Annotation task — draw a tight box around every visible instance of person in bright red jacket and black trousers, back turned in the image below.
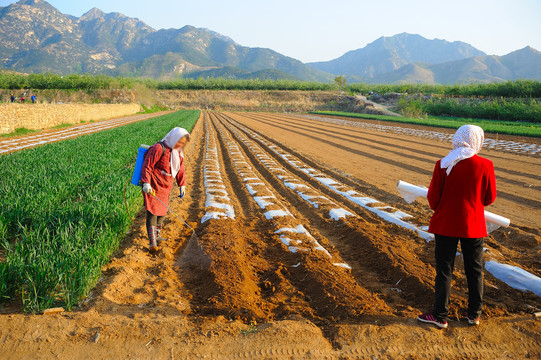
[417,125,496,328]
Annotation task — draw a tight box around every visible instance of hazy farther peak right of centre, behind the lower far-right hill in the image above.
[309,33,485,82]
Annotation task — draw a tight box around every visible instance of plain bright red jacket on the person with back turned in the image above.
[428,155,496,238]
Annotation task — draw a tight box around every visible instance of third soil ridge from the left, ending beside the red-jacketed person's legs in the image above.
[214,112,434,307]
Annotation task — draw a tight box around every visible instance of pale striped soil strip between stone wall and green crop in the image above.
[0,111,171,154]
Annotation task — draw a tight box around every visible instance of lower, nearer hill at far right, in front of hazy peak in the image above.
[370,46,541,84]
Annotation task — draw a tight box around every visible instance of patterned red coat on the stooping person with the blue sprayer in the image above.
[141,143,186,216]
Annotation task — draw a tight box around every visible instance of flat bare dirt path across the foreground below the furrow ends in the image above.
[0,311,541,360]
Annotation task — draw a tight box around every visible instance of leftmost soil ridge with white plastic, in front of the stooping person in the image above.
[184,114,273,322]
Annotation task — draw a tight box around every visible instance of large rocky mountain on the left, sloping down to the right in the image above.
[0,0,331,81]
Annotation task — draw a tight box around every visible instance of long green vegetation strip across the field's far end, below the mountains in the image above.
[0,71,541,98]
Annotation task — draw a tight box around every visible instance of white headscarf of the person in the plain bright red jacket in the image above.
[441,125,485,175]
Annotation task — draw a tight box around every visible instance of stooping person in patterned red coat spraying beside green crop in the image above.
[141,127,190,252]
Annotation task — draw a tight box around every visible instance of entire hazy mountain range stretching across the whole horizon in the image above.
[0,0,541,84]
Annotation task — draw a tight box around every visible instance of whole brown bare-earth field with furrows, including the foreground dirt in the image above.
[0,113,541,359]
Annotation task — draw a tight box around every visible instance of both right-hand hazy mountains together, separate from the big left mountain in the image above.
[308,33,541,84]
